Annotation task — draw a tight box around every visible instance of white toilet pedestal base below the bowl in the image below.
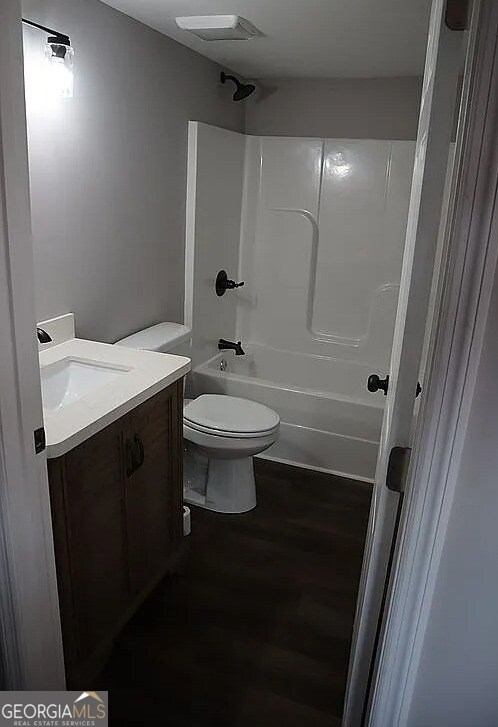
[184,447,257,514]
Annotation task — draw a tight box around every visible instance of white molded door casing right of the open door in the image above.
[369,0,498,727]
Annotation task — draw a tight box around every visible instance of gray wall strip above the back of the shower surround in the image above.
[246,77,422,139]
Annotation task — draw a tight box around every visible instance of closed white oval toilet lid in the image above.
[183,394,280,435]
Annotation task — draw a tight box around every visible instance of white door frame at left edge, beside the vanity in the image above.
[0,0,65,690]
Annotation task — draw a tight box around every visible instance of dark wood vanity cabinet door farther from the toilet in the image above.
[51,422,131,660]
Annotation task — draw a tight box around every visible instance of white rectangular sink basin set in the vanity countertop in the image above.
[41,357,131,411]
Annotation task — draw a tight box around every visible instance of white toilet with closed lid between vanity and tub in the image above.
[116,323,280,513]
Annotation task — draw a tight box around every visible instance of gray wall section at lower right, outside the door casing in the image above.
[408,260,498,727]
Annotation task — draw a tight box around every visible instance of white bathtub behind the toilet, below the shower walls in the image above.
[192,344,383,482]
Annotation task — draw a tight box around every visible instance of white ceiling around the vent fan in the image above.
[97,0,430,78]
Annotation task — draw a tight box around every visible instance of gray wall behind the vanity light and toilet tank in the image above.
[23,0,244,341]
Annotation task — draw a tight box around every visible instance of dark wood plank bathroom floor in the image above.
[94,460,371,727]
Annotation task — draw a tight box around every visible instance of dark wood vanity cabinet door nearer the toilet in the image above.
[126,382,183,594]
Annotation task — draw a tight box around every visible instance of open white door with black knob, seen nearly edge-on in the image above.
[343,0,465,727]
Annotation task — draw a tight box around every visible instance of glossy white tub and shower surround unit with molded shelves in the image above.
[185,122,415,480]
